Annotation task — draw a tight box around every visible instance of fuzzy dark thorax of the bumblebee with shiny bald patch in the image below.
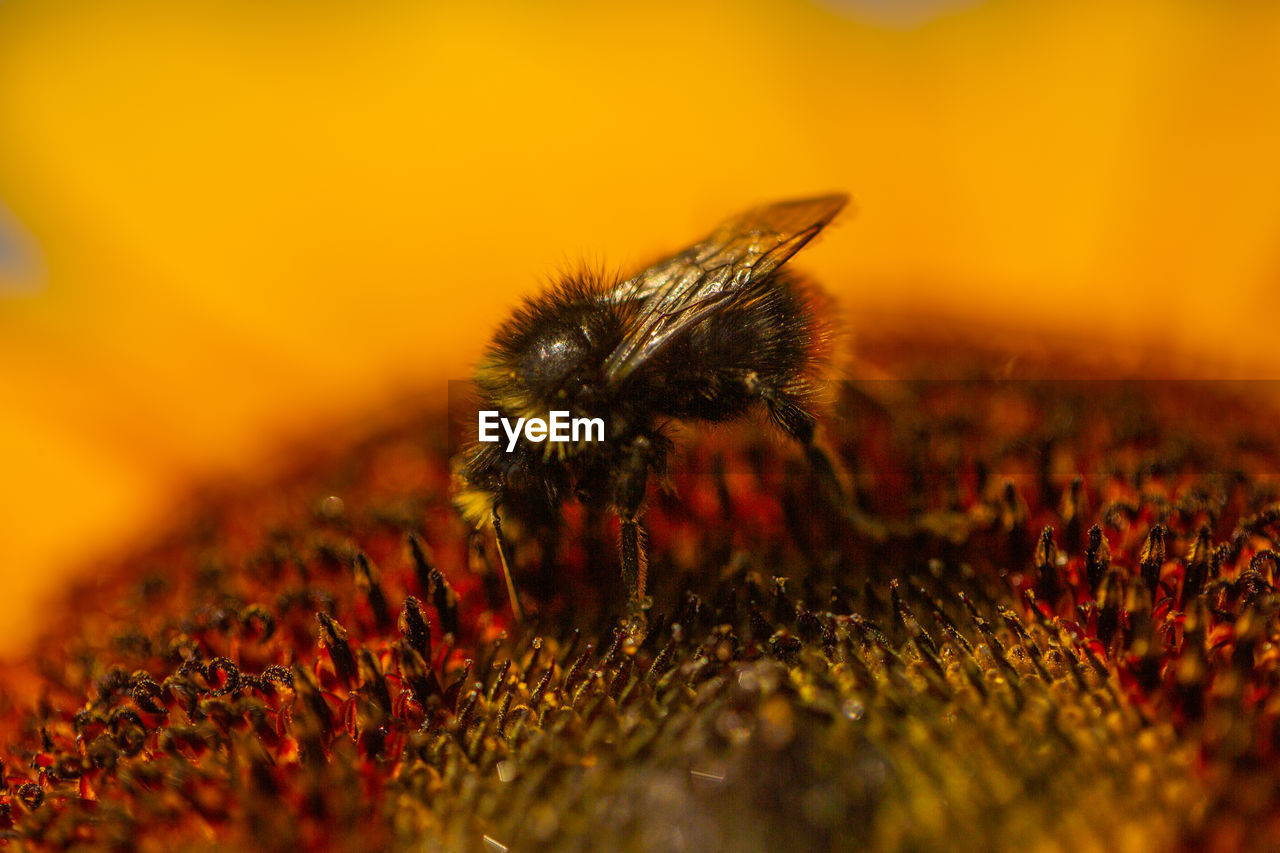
[476,277,627,418]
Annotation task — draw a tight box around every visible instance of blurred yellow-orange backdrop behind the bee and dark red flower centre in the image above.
[0,0,1280,651]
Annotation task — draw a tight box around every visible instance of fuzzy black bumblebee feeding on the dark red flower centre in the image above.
[453,195,849,621]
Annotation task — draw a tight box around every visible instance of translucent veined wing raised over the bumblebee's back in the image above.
[604,195,849,386]
